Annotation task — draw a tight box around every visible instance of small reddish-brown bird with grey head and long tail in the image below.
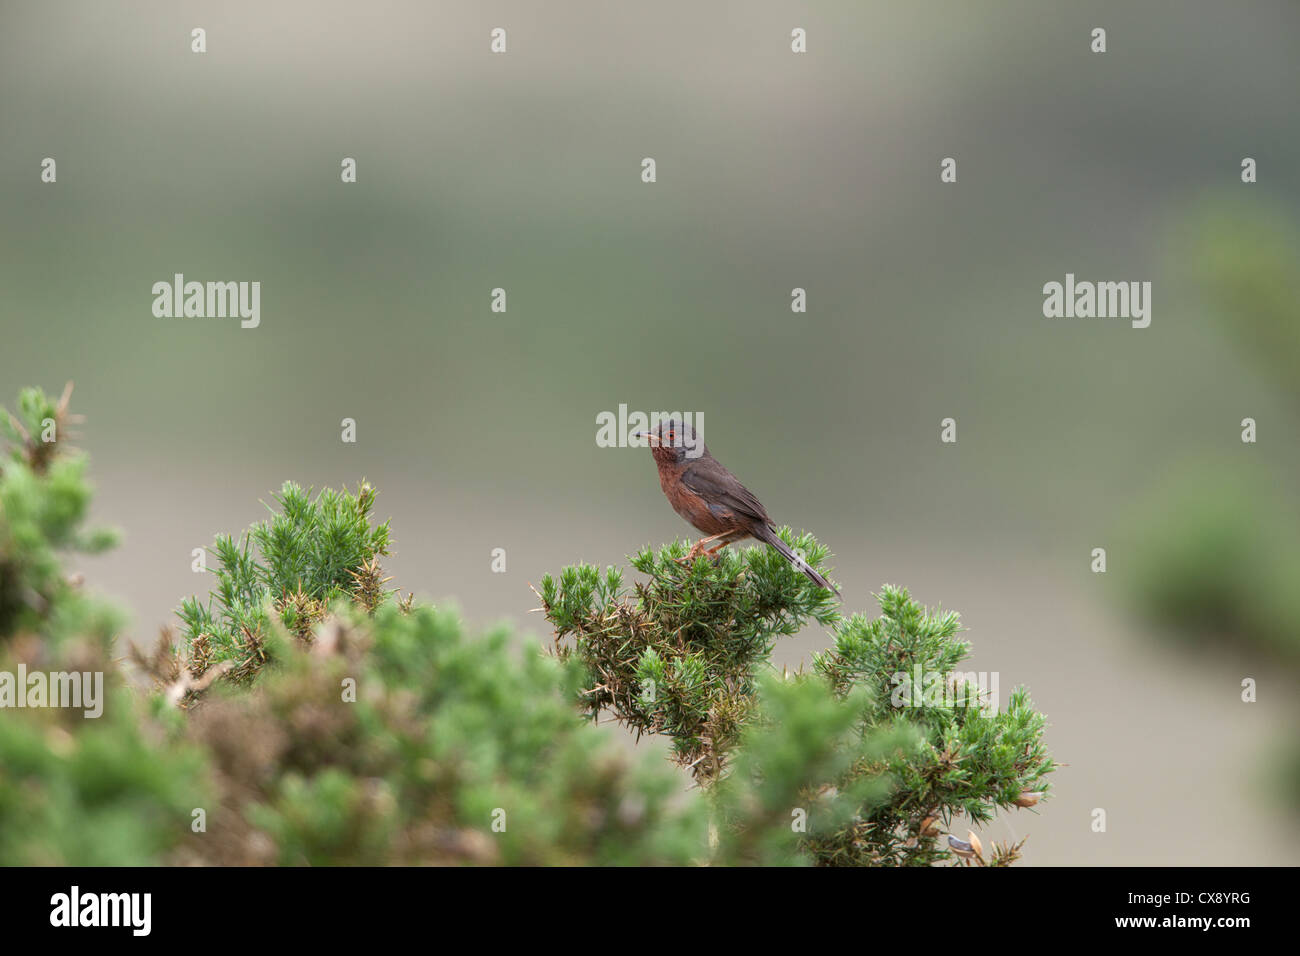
[633,419,840,597]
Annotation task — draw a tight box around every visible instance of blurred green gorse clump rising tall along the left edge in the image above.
[0,386,208,865]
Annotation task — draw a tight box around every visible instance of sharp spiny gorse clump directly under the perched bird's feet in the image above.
[538,528,839,780]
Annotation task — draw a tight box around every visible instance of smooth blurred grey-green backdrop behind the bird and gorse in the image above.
[0,1,1300,864]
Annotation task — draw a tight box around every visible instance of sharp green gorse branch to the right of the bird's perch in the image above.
[814,585,1056,864]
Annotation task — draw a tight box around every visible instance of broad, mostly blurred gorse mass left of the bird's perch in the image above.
[0,382,707,865]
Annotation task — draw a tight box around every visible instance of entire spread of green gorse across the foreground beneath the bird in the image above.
[0,382,1052,865]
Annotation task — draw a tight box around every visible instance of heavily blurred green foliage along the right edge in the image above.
[1133,208,1300,808]
